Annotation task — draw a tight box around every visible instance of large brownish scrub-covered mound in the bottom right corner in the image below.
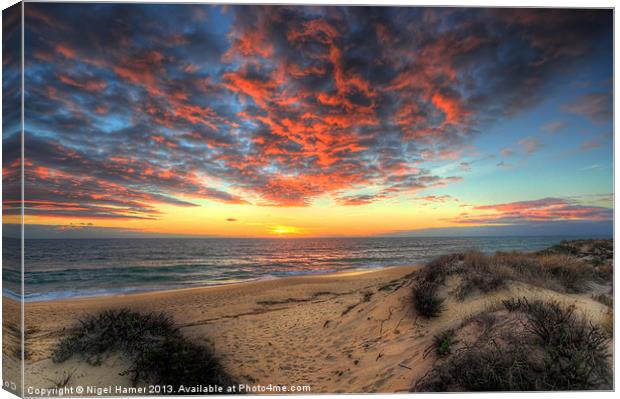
[413,299,612,392]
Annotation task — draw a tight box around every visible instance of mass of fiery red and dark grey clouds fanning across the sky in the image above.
[19,4,609,217]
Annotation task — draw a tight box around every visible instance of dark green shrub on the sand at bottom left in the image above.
[52,309,234,393]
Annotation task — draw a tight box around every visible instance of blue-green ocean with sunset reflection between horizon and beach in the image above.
[3,236,604,301]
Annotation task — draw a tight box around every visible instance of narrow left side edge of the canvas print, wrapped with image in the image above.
[2,2,25,396]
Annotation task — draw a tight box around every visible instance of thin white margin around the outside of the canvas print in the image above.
[0,0,619,399]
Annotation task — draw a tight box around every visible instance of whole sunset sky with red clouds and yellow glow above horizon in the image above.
[3,3,613,237]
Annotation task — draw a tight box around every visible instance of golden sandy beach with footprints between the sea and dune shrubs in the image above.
[3,255,606,393]
